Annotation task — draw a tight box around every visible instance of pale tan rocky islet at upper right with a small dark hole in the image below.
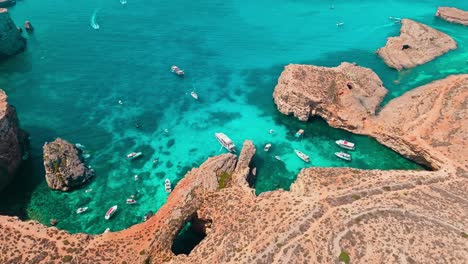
[377,19,457,70]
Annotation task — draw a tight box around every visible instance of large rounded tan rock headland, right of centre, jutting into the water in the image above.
[273,62,387,129]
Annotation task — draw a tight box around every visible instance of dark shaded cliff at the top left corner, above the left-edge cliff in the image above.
[0,8,26,59]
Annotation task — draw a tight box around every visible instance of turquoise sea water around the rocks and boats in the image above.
[0,0,468,233]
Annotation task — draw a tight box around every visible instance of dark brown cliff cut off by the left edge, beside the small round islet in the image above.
[0,90,28,190]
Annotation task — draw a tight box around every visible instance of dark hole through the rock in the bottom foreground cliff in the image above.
[172,213,211,255]
